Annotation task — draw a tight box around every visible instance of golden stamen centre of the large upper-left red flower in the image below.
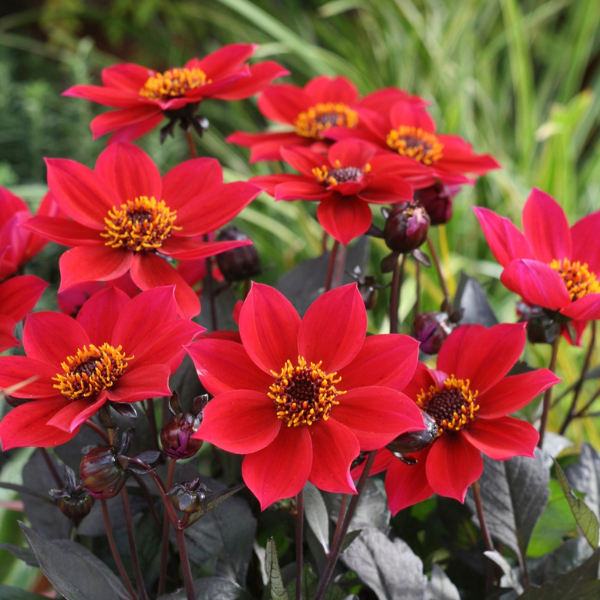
[100,196,181,252]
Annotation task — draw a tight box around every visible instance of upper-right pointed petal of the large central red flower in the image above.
[298,283,367,373]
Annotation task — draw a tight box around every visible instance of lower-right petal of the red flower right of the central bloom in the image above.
[462,417,540,460]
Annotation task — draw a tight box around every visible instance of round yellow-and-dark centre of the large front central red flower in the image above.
[267,356,346,427]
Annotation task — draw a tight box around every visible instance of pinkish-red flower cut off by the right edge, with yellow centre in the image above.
[473,188,600,342]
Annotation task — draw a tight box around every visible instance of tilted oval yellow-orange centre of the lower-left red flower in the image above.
[52,344,133,400]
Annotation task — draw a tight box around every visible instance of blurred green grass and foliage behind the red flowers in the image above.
[0,0,600,587]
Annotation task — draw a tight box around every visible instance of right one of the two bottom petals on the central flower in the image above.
[308,419,360,494]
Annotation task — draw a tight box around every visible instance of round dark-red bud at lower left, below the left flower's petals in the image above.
[79,446,129,500]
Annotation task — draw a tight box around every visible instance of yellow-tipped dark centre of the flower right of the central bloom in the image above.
[417,375,479,437]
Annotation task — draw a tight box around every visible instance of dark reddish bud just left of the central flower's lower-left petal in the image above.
[160,392,208,460]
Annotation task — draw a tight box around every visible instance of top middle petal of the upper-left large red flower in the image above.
[96,144,163,206]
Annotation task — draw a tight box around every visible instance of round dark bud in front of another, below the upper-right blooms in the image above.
[383,202,430,254]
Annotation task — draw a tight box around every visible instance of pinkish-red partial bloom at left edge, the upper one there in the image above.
[0,187,58,281]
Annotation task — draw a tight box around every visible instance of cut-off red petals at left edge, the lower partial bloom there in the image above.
[0,275,48,352]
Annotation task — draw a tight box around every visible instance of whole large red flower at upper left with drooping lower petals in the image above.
[25,144,260,318]
